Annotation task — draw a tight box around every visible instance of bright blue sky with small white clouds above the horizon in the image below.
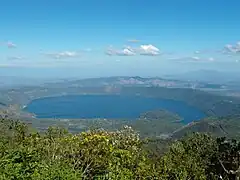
[0,0,240,77]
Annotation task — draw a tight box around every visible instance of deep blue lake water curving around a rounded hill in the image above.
[25,95,205,123]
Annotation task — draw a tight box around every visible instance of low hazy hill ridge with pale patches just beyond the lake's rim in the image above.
[39,76,224,89]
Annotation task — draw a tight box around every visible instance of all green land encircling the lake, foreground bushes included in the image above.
[0,79,240,180]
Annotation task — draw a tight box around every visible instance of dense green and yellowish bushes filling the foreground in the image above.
[0,117,240,180]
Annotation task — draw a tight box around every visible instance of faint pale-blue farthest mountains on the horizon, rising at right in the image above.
[0,70,240,88]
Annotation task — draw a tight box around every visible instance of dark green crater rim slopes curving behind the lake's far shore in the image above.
[0,81,240,116]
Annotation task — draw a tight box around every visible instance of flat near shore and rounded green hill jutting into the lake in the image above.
[16,109,184,137]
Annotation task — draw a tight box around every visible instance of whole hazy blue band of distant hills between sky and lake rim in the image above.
[0,74,236,93]
